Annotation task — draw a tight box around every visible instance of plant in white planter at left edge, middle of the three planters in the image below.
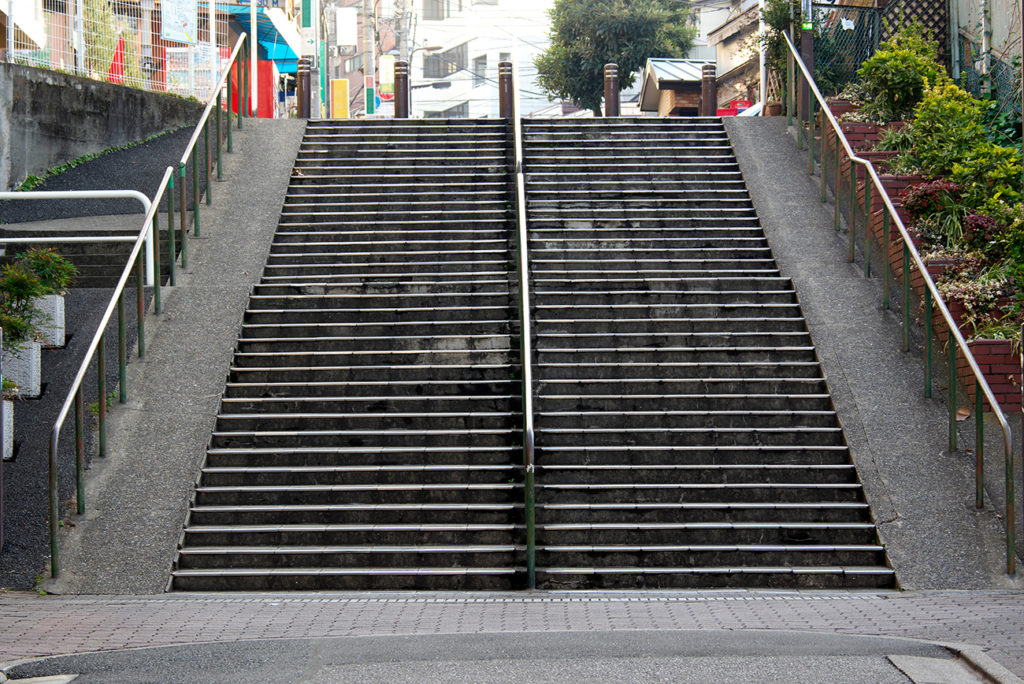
[0,263,43,397]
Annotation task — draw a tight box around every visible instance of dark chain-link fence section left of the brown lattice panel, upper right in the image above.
[813,4,881,95]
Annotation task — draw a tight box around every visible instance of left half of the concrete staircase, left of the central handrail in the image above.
[172,120,524,591]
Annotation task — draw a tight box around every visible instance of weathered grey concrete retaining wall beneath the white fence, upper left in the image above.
[0,63,204,189]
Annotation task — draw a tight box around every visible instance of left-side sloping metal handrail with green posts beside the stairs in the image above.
[48,33,249,578]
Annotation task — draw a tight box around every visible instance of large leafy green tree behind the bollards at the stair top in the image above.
[534,0,696,116]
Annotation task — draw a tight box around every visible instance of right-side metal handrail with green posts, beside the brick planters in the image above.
[782,32,1017,574]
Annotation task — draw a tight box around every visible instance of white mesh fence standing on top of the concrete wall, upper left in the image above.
[7,0,230,99]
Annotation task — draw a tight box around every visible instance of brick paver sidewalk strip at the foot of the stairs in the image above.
[0,591,1024,675]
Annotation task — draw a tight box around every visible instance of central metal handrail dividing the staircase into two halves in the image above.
[511,56,537,589]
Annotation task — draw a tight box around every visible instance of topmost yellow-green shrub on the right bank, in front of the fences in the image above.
[857,24,948,121]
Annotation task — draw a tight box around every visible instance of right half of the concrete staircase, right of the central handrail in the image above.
[524,119,894,589]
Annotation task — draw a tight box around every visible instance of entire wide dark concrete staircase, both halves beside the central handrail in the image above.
[171,114,894,591]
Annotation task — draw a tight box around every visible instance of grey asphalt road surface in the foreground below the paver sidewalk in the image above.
[2,631,958,684]
